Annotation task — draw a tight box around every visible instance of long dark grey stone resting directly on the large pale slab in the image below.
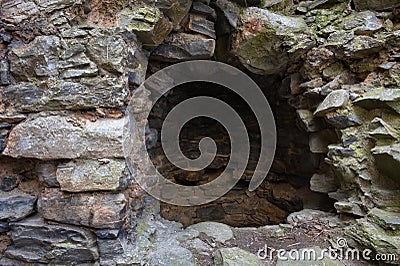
[3,77,128,112]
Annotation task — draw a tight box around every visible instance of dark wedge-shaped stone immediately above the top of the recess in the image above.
[151,33,215,62]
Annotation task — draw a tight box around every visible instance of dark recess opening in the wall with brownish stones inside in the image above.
[149,76,333,227]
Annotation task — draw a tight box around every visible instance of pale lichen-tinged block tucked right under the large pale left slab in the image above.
[56,159,126,192]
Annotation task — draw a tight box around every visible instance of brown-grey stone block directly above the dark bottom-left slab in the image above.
[38,189,127,229]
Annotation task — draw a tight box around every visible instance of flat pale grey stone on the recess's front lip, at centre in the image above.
[187,222,233,243]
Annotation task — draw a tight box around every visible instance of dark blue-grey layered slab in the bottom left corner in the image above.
[5,216,99,265]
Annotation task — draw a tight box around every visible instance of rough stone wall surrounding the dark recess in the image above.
[0,0,400,265]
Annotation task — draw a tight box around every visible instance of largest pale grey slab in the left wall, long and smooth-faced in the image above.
[3,115,124,159]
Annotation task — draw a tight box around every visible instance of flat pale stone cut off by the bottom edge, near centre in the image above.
[214,247,264,266]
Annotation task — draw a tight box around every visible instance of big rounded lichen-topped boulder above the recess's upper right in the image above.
[232,7,311,75]
